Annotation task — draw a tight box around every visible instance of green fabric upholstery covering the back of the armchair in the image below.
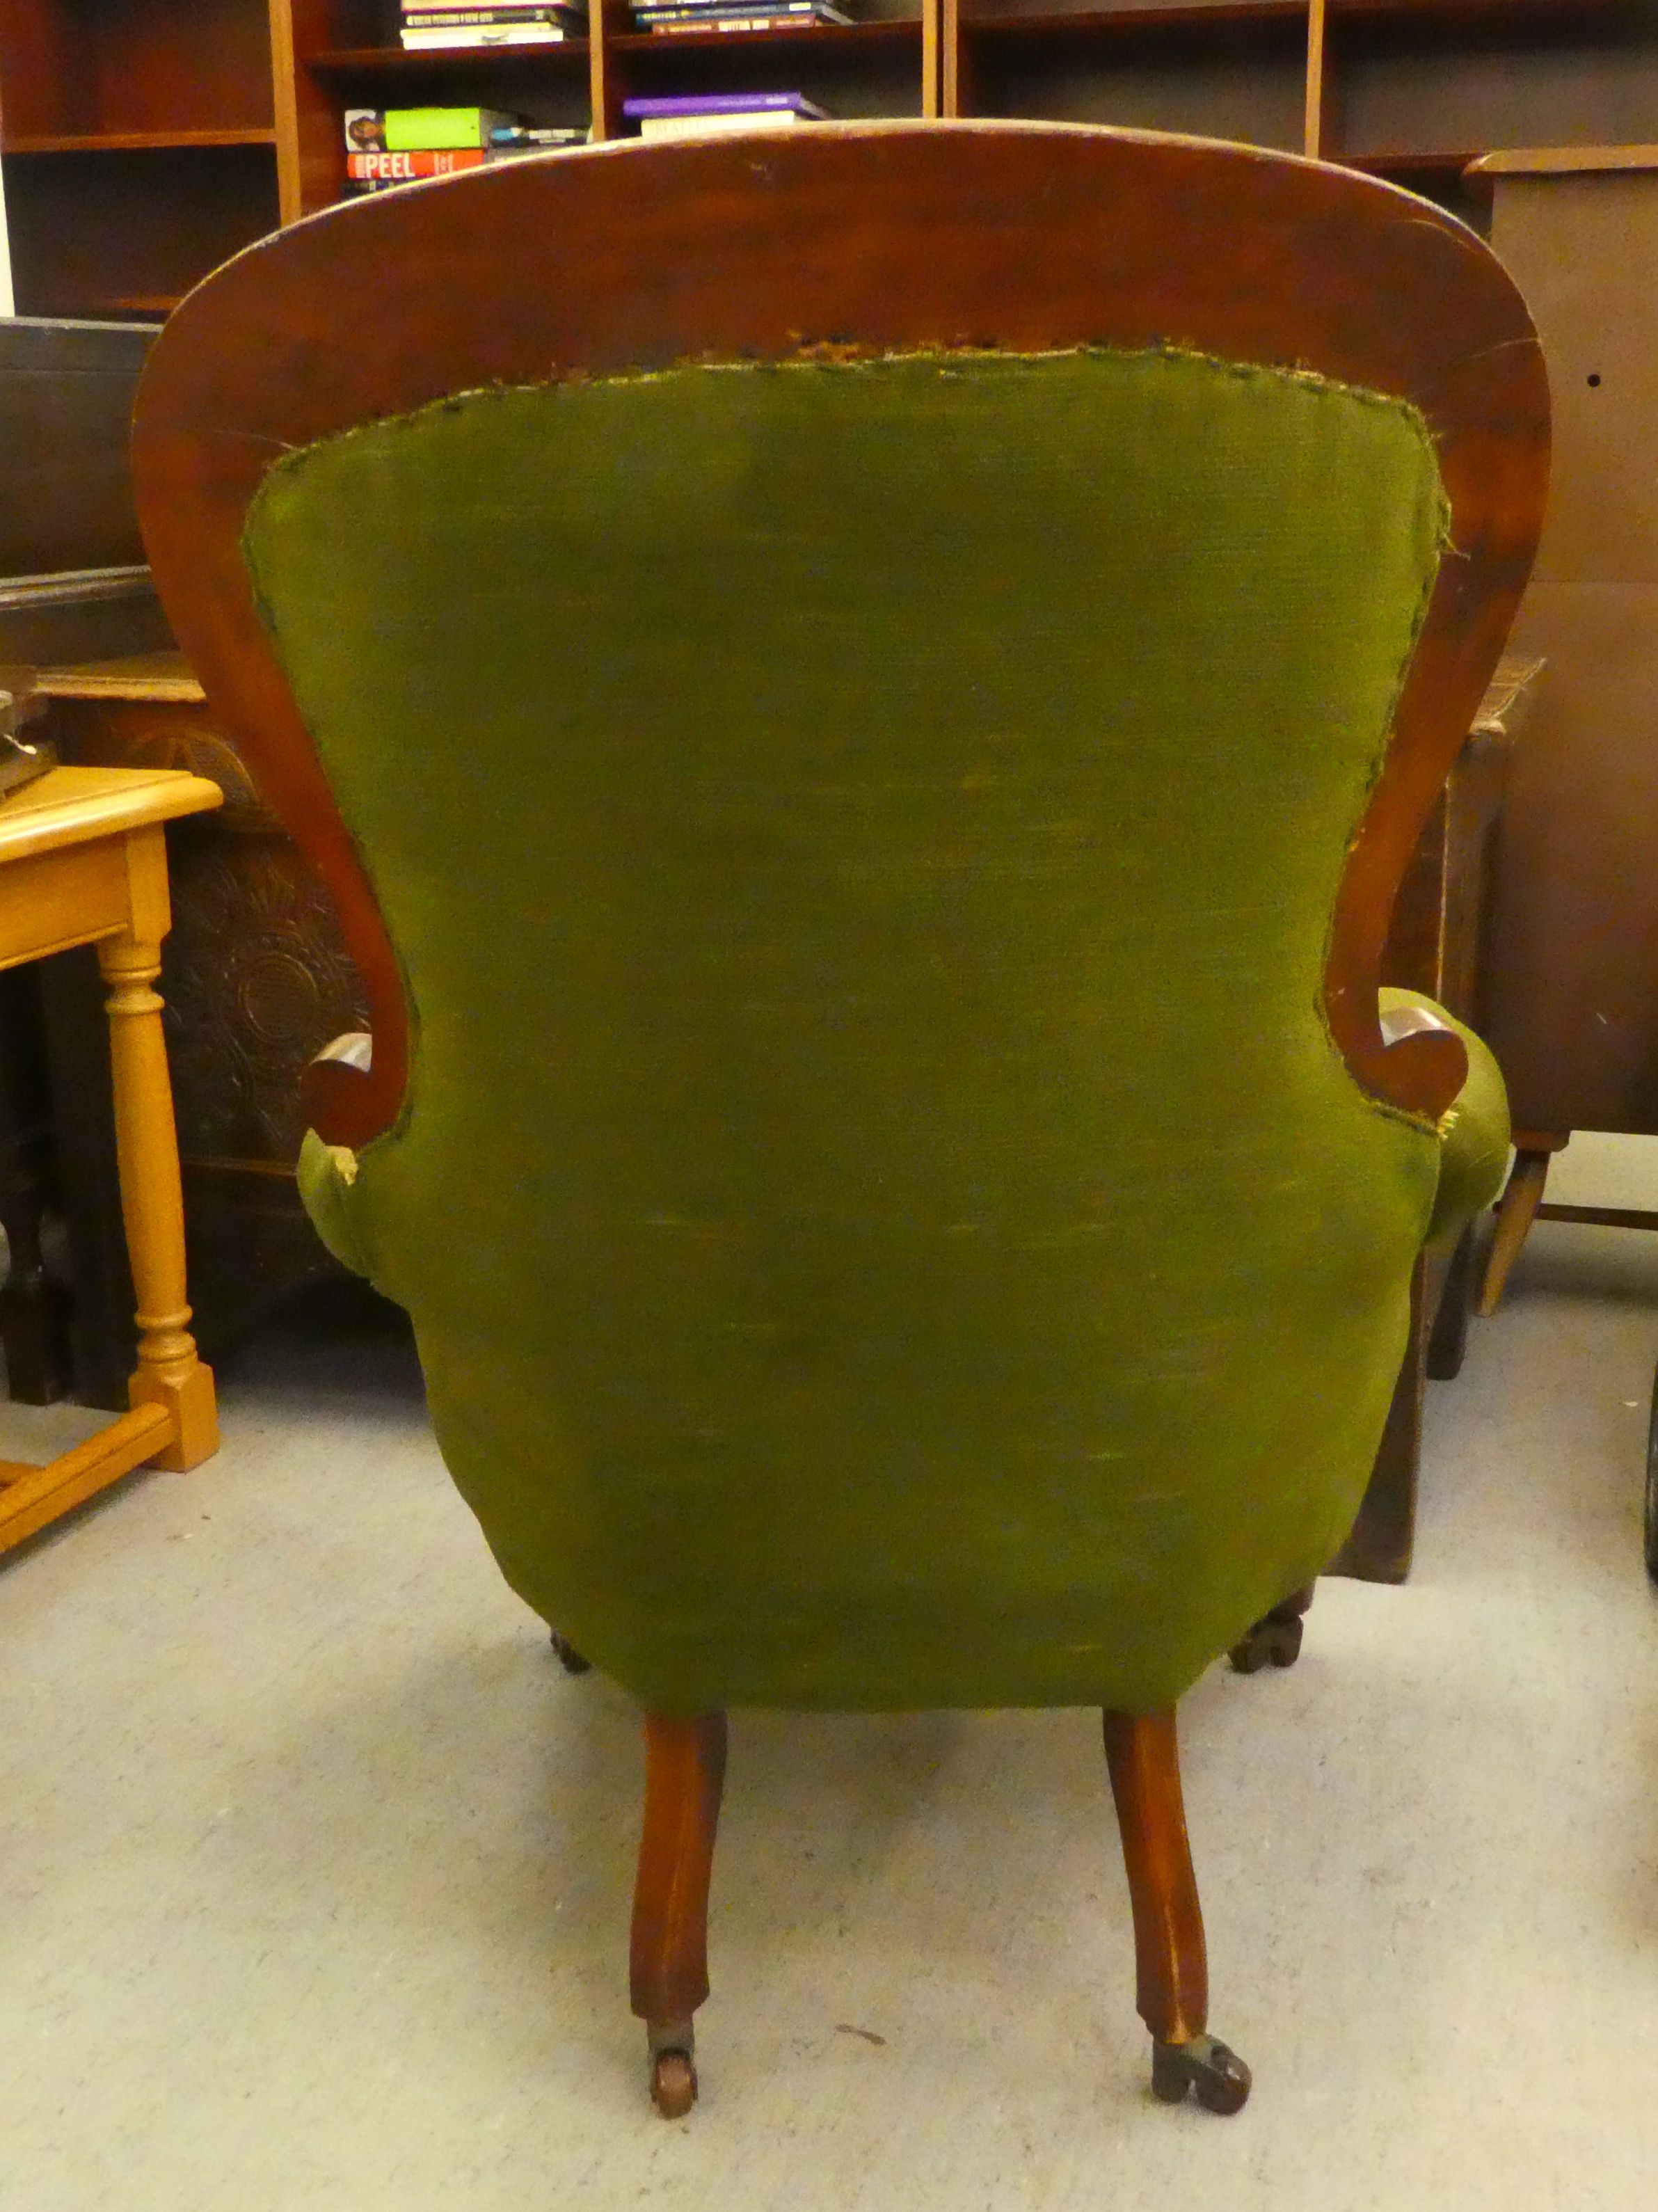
[256,351,1503,1712]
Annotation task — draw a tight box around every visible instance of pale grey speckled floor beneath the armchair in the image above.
[0,1225,1658,2212]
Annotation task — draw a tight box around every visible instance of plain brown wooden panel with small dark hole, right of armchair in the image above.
[1483,161,1658,1135]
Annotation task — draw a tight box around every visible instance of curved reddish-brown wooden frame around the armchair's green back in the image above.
[135,124,1549,1144]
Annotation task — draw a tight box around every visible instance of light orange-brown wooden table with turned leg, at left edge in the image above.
[0,767,221,1550]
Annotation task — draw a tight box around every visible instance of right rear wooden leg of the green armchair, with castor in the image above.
[1106,1712,1249,2112]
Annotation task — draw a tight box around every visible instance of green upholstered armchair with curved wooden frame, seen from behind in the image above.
[135,126,1547,2112]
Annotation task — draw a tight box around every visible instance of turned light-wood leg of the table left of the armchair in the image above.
[97,827,219,1473]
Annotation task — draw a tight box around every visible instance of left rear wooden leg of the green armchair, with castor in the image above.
[628,1712,725,2119]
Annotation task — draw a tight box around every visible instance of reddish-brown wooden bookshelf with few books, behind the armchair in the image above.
[0,0,1658,317]
